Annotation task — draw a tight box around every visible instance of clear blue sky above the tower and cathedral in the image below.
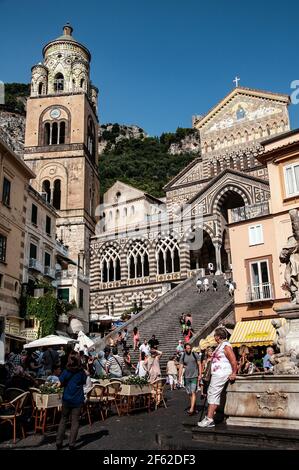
[0,0,299,135]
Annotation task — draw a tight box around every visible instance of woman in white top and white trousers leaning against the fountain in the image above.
[197,327,238,428]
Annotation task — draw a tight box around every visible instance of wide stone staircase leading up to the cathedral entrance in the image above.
[96,276,233,371]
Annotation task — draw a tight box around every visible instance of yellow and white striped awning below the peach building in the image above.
[229,318,286,347]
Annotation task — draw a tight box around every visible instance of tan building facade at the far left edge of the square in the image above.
[0,140,34,362]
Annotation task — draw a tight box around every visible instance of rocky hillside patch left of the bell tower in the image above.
[0,111,26,155]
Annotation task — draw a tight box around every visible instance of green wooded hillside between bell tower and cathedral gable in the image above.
[99,128,196,197]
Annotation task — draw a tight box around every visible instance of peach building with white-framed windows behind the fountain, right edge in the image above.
[229,129,299,321]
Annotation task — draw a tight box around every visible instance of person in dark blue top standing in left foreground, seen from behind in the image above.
[55,353,88,450]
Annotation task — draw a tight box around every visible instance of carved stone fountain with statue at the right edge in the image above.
[225,209,299,430]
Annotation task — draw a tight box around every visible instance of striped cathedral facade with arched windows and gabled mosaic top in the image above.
[90,87,290,324]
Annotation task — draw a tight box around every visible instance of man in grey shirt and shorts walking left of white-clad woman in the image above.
[179,343,201,416]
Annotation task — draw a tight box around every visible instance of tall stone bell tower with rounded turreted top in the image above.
[24,23,99,326]
